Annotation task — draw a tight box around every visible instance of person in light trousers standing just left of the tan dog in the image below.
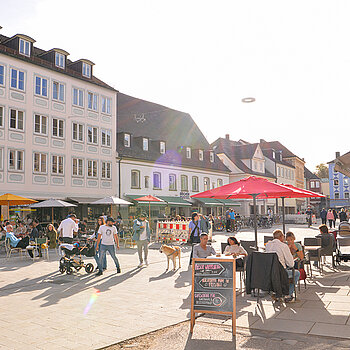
[132,212,151,267]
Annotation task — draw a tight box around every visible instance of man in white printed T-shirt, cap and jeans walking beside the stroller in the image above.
[96,217,121,276]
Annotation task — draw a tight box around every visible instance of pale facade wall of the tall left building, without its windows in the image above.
[0,54,117,199]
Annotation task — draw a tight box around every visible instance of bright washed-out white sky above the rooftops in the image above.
[0,0,350,171]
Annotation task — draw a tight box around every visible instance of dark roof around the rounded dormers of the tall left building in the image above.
[0,34,117,91]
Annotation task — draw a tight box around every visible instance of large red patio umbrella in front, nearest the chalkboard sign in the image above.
[191,176,308,247]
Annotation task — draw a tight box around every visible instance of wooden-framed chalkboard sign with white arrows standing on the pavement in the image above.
[191,258,236,334]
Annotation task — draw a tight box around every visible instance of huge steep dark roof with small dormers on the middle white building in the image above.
[117,92,229,173]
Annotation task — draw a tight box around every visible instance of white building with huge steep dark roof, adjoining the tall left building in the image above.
[117,93,233,216]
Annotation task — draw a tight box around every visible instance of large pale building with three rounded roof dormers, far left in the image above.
[0,30,117,216]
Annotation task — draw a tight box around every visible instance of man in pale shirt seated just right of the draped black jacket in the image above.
[265,230,300,303]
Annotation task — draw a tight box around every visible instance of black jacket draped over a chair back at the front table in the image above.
[246,252,289,298]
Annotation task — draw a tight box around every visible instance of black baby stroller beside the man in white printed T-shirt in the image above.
[59,242,95,275]
